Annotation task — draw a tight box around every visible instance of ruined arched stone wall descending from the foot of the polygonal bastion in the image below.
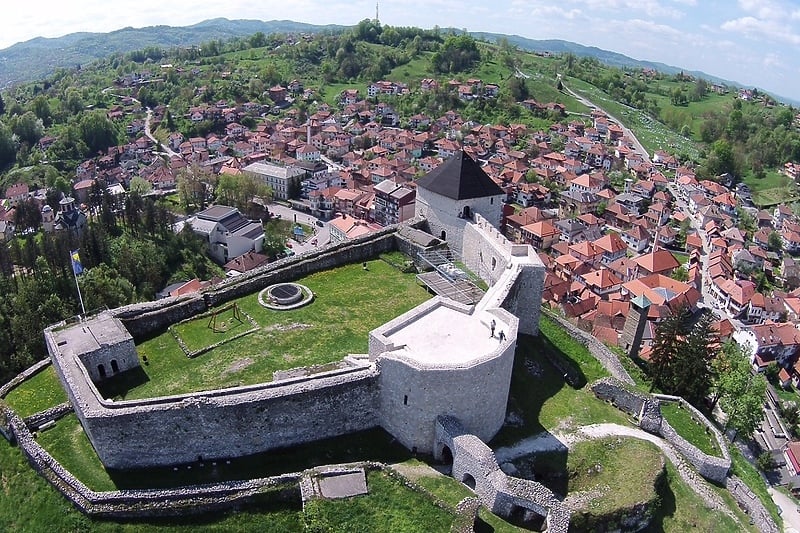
[434,417,570,533]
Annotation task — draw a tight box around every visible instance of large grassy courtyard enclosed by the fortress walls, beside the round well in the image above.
[108,260,430,399]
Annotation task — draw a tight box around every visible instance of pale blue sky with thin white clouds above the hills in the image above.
[0,0,800,100]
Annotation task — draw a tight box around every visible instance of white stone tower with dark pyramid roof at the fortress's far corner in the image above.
[415,151,505,253]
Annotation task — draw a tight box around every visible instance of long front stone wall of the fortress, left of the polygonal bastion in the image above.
[72,364,379,469]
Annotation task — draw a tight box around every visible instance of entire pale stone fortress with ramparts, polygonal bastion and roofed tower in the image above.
[44,149,569,530]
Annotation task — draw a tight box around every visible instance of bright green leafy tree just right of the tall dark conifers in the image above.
[713,342,767,438]
